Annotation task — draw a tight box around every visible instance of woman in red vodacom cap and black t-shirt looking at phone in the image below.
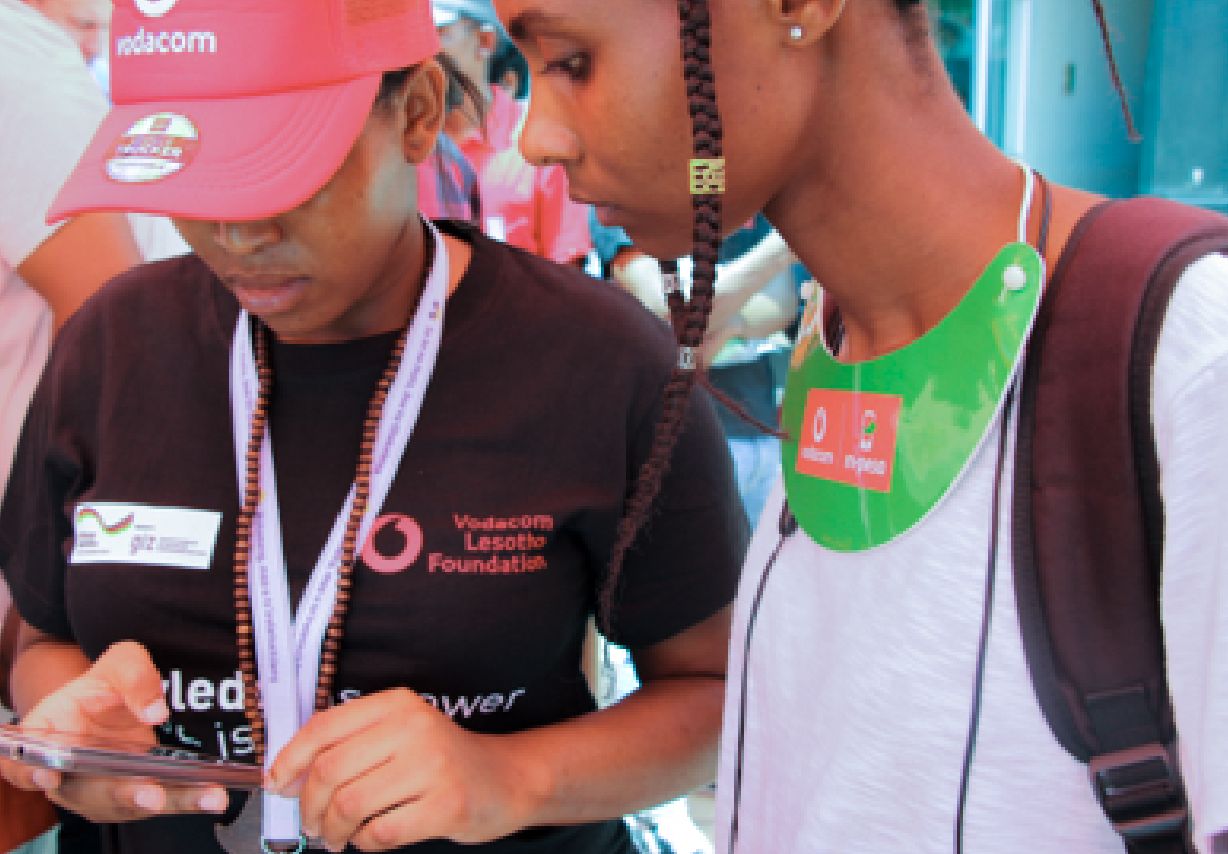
[0,0,747,854]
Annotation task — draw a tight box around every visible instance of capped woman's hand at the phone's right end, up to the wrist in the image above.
[266,688,538,852]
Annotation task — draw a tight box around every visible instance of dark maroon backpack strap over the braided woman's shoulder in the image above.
[1012,199,1228,854]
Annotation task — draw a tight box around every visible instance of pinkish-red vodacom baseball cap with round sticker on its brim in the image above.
[47,0,440,222]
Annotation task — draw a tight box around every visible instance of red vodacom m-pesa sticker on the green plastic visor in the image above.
[797,388,903,493]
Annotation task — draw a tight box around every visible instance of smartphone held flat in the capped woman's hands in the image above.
[0,725,262,790]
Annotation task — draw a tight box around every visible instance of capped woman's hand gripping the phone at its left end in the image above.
[0,641,227,823]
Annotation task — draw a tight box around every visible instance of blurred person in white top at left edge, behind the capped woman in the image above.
[0,0,151,850]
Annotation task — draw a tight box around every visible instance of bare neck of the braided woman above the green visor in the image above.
[765,33,1039,360]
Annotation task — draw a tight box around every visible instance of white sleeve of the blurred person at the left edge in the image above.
[0,0,107,268]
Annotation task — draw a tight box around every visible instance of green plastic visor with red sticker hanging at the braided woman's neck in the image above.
[781,243,1044,552]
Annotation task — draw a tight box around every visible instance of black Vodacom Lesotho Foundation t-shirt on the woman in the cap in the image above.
[0,222,747,854]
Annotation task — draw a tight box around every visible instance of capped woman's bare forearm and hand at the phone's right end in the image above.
[265,606,731,852]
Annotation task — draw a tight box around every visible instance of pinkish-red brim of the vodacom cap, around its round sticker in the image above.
[47,75,381,222]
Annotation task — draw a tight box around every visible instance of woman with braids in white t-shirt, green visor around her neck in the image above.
[495,0,1228,854]
